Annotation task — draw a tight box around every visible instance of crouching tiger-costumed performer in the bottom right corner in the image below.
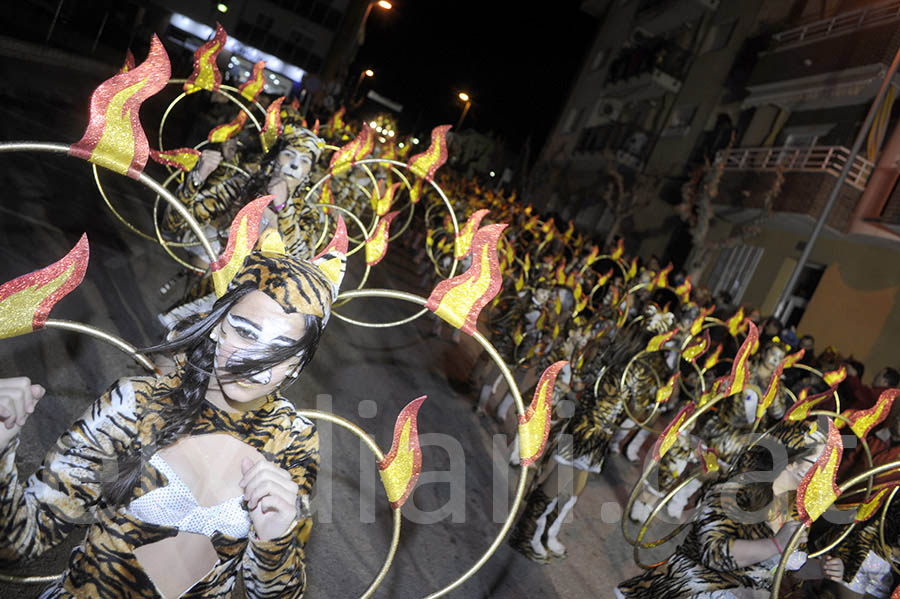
[615,422,844,599]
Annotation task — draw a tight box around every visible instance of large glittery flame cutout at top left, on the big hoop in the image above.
[69,35,171,179]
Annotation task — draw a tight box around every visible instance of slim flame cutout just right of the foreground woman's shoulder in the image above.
[378,395,427,509]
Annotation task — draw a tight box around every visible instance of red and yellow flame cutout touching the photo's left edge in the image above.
[0,234,90,339]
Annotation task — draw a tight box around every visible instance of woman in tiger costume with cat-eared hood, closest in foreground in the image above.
[0,223,344,599]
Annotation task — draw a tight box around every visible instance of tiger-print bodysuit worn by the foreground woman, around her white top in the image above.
[0,373,318,599]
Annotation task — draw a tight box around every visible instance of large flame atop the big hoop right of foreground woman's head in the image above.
[425,224,506,335]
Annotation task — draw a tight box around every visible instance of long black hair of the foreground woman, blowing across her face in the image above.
[103,282,322,506]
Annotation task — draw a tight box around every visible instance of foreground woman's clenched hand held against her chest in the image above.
[240,458,300,541]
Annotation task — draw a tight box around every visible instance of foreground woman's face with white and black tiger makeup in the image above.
[213,291,306,403]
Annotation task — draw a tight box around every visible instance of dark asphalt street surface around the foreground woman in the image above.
[0,58,656,599]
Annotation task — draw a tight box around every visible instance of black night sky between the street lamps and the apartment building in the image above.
[350,0,597,155]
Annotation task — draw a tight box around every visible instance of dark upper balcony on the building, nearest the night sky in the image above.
[603,38,691,101]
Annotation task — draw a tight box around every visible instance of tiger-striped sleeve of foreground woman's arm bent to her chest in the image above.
[243,416,319,599]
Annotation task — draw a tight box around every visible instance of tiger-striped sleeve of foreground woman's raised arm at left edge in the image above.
[0,380,137,565]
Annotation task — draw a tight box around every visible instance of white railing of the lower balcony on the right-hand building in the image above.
[716,146,875,190]
